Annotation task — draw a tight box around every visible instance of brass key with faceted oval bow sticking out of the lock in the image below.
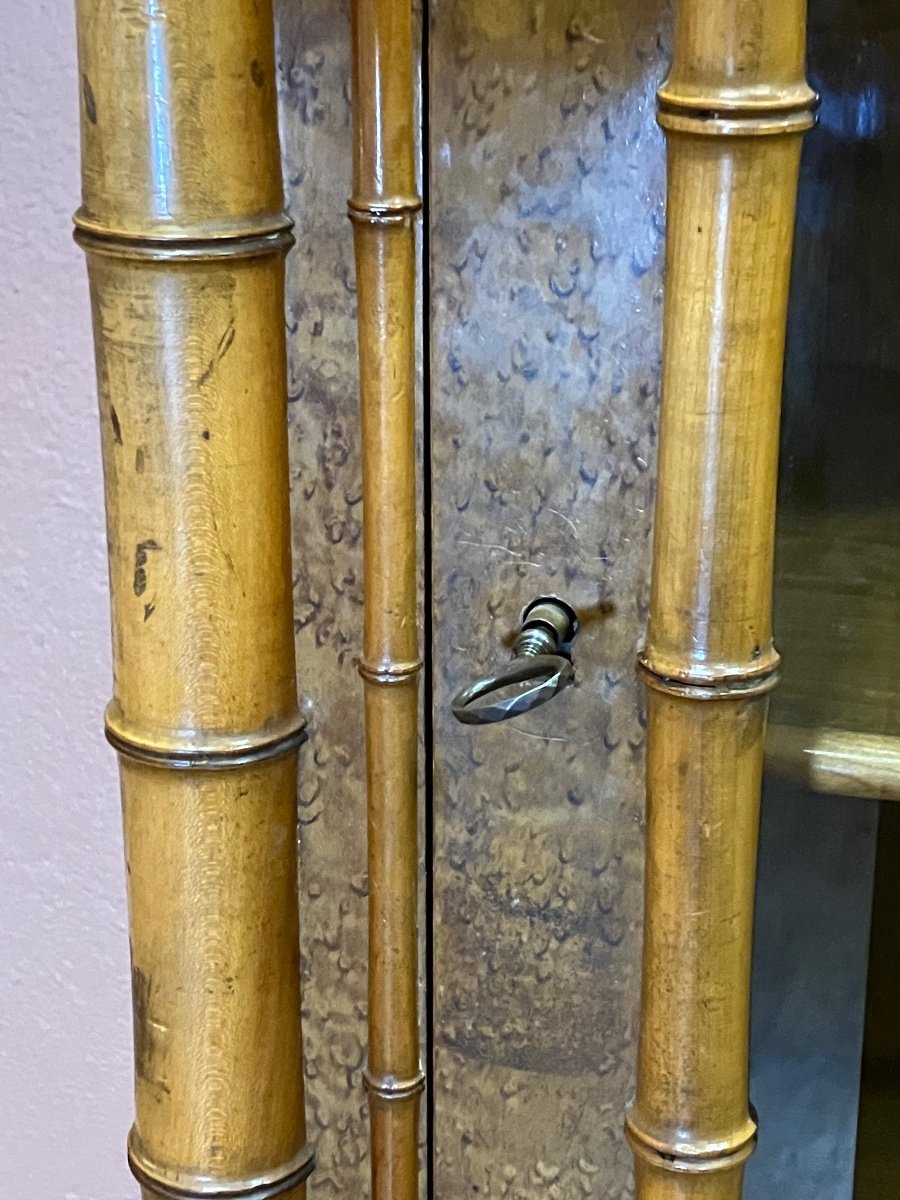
[451,596,578,725]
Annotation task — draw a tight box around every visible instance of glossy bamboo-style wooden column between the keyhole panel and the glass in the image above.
[628,0,814,1200]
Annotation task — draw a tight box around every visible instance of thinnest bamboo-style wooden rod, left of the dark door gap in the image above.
[349,0,425,1200]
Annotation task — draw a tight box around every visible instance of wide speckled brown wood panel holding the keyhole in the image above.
[430,0,668,1200]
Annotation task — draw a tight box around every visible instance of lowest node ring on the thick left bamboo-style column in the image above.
[128,1127,316,1200]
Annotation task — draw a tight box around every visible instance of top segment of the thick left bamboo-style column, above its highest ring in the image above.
[78,0,286,241]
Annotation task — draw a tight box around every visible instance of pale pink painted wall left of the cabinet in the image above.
[0,0,137,1200]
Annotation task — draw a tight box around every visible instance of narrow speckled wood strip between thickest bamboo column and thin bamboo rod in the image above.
[276,0,424,1198]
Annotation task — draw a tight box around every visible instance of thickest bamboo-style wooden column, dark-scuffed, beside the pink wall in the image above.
[76,0,312,1200]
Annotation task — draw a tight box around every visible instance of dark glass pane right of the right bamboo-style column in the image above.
[745,0,900,1200]
